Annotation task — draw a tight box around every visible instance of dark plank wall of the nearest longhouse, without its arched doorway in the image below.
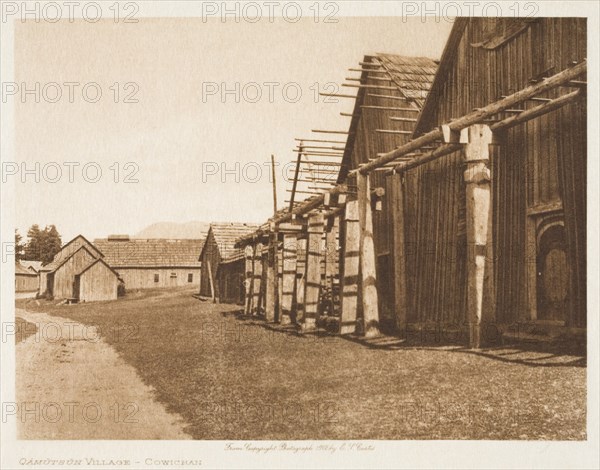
[405,18,586,326]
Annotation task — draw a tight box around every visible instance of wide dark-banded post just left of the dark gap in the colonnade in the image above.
[302,213,325,331]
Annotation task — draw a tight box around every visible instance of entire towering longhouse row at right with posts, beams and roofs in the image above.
[233,18,587,347]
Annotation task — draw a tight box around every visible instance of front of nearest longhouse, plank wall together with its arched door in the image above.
[402,18,587,334]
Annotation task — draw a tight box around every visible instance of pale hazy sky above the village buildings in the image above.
[15,17,452,241]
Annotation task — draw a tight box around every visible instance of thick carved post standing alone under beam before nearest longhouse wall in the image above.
[464,124,492,348]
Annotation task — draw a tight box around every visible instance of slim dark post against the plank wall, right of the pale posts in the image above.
[390,174,407,332]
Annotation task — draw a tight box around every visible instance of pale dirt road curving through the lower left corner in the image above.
[15,309,190,439]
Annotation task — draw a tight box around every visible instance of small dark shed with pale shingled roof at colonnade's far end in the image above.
[199,222,258,303]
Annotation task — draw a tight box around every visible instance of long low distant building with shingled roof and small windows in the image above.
[94,235,204,290]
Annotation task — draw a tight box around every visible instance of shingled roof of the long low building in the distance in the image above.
[94,238,204,269]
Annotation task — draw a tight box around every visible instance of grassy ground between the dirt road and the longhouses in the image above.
[19,290,586,440]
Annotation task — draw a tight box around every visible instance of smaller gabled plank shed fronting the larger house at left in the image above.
[73,258,119,302]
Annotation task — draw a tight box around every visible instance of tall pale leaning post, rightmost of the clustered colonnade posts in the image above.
[356,173,379,338]
